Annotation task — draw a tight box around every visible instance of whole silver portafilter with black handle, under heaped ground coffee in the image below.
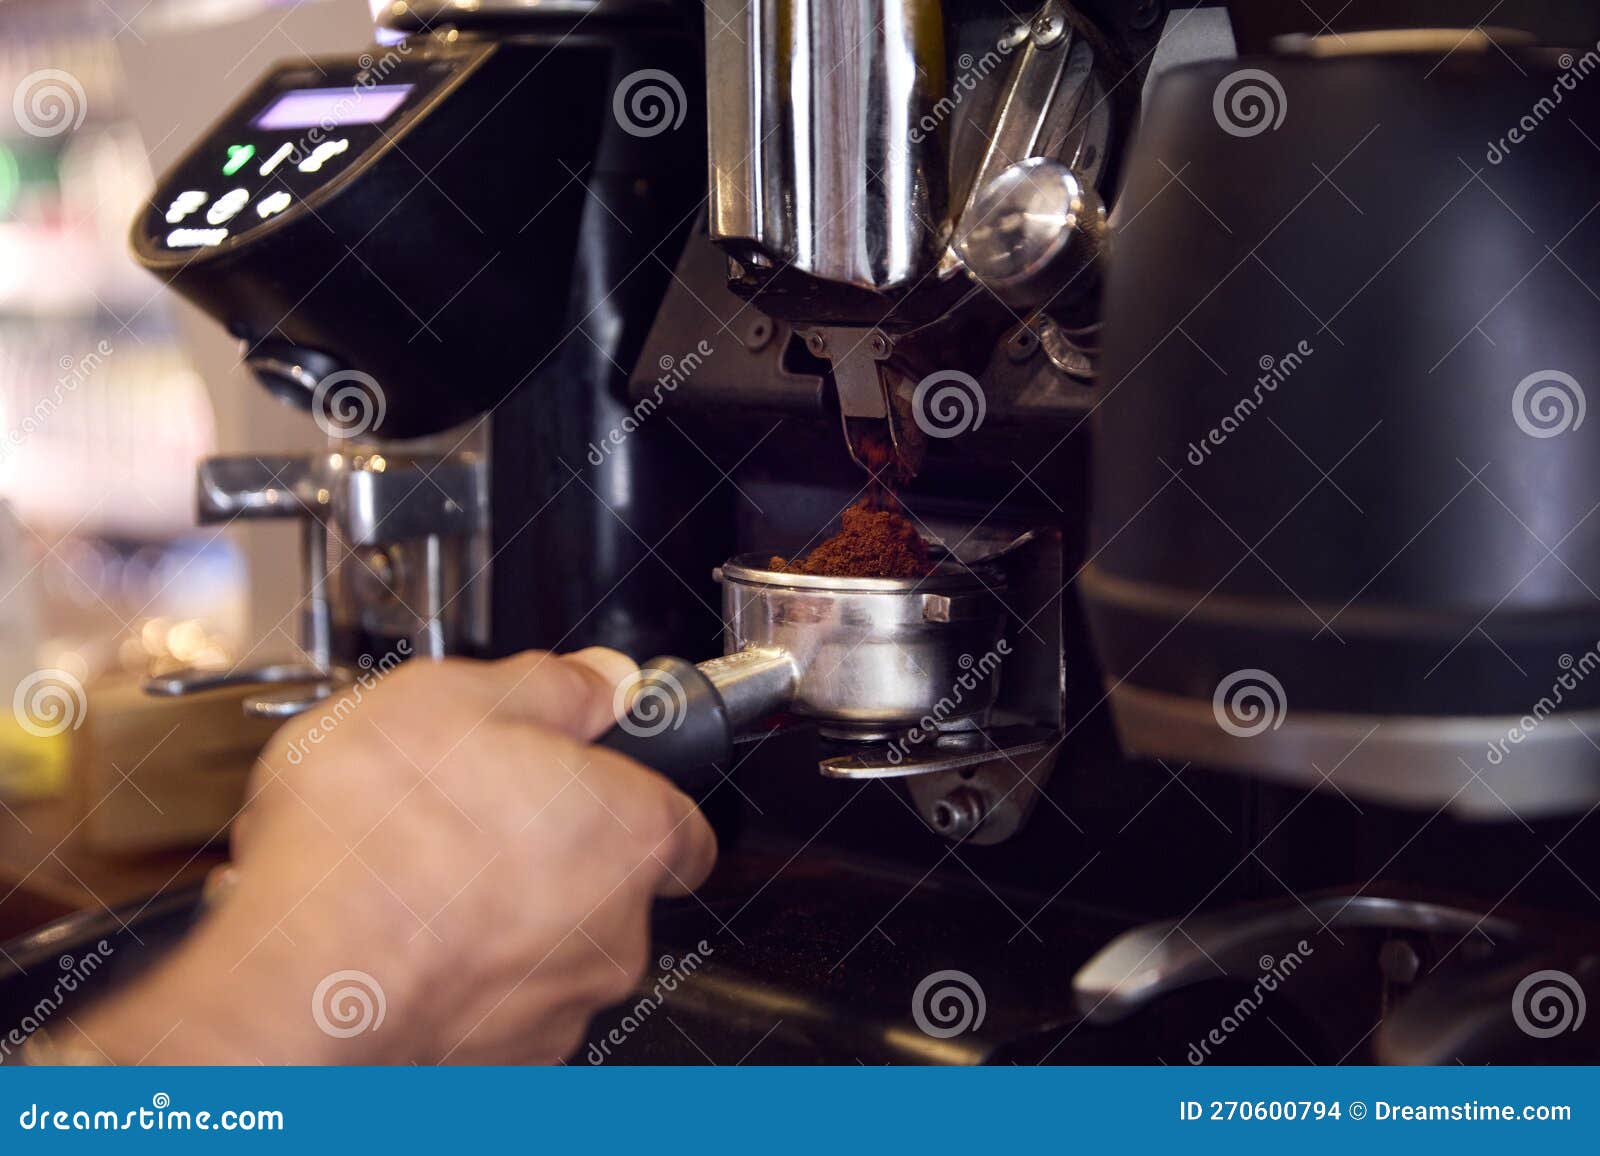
[602,554,1006,793]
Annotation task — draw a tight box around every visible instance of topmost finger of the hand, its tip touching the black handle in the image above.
[482,647,638,741]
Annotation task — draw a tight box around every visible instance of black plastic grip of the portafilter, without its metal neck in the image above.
[597,655,733,802]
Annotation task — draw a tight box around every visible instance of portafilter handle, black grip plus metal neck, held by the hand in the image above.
[597,647,800,802]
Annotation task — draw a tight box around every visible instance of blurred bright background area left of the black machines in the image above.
[0,0,371,947]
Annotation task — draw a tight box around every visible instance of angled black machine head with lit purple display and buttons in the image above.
[133,37,610,437]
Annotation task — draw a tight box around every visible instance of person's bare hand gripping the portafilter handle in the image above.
[82,648,717,1063]
